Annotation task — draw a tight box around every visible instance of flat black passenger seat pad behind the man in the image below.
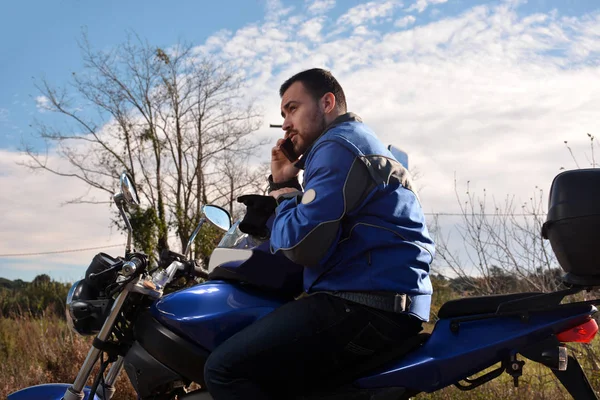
[438,292,542,319]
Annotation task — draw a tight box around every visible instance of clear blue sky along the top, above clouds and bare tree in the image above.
[0,0,598,150]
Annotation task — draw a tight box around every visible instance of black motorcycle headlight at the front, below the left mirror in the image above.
[65,280,109,335]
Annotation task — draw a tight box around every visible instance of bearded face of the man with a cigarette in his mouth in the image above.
[281,82,326,155]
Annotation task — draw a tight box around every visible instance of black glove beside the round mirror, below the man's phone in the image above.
[237,194,277,238]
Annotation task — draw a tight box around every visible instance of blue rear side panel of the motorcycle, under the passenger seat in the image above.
[356,304,596,393]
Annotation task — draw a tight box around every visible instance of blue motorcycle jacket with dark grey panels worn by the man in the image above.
[270,113,435,321]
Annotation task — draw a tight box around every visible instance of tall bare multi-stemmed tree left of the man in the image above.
[25,35,264,260]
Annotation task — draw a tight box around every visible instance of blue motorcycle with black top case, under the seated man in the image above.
[8,164,600,400]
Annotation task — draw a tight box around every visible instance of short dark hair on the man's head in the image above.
[279,68,347,112]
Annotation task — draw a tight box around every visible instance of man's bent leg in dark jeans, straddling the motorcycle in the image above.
[205,294,420,400]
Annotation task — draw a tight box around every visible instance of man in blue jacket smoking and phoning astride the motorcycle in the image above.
[205,69,434,400]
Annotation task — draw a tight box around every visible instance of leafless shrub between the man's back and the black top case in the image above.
[434,177,560,294]
